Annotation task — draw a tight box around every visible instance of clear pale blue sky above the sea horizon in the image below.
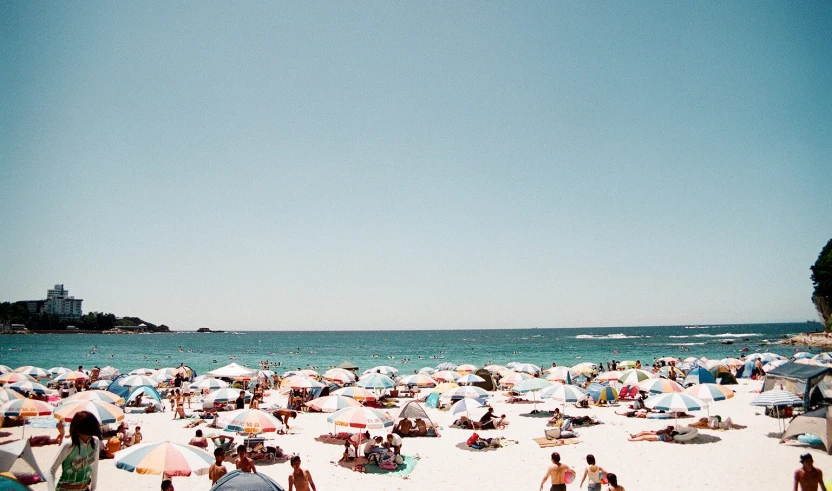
[0,1,832,329]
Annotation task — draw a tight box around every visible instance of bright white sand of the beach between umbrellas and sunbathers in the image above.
[11,380,832,491]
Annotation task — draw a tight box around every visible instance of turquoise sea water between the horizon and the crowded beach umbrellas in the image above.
[0,323,818,373]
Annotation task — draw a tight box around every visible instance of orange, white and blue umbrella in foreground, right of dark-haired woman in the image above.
[115,442,214,477]
